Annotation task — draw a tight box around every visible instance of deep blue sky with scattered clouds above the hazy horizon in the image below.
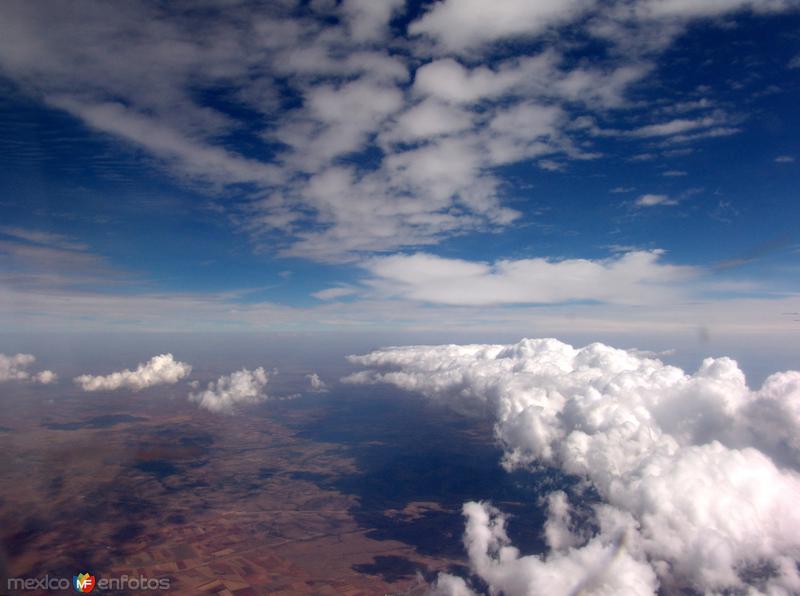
[0,0,800,337]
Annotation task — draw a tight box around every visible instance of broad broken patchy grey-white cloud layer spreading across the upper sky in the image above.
[0,0,791,261]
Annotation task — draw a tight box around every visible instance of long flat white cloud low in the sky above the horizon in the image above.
[365,250,699,305]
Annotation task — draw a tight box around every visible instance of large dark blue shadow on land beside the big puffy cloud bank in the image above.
[278,387,574,560]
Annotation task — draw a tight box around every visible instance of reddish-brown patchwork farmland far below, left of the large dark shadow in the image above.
[0,384,482,595]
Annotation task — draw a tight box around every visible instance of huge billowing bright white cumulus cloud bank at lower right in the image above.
[345,339,800,595]
